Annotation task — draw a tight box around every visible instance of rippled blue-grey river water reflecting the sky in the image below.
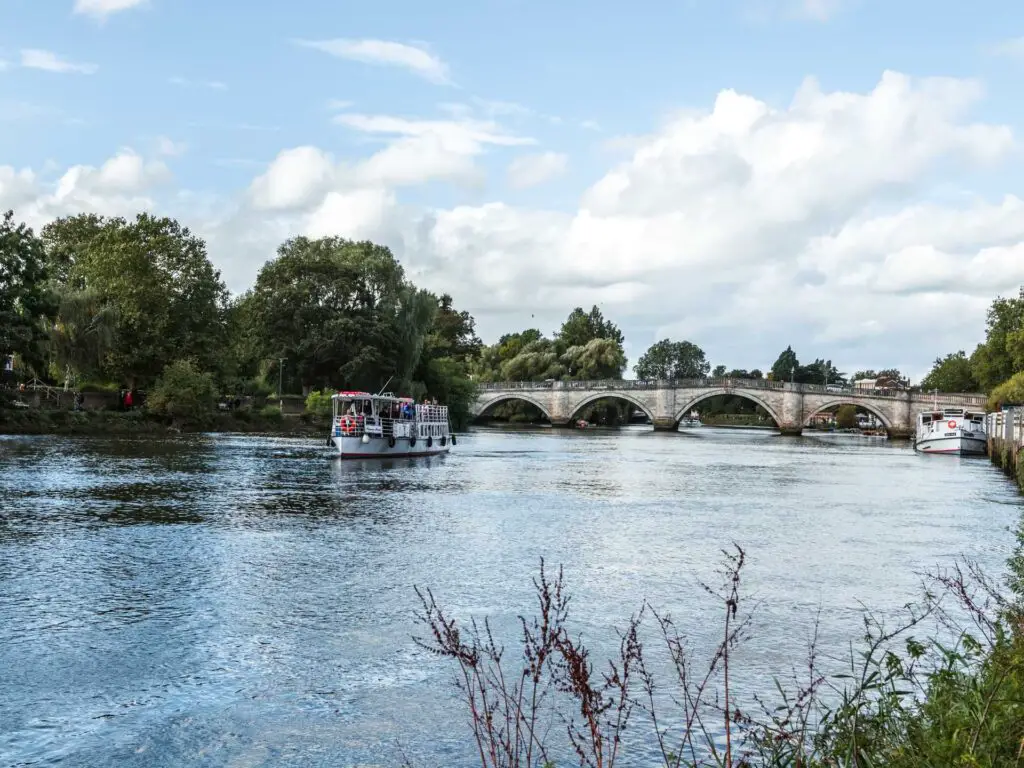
[0,428,1021,767]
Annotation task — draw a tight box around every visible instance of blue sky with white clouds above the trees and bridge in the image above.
[0,0,1024,379]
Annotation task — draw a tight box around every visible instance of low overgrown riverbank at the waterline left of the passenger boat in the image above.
[0,409,328,436]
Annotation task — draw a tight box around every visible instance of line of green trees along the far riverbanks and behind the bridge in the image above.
[8,207,1024,438]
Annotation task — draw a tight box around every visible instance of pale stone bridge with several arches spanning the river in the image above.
[473,379,986,437]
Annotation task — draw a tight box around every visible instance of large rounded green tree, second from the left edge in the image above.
[42,213,227,386]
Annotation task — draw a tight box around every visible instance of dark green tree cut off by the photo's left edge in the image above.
[0,211,53,366]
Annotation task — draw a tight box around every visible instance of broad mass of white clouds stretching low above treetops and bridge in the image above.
[0,73,1024,382]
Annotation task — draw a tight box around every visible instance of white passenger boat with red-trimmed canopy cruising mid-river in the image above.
[329,392,456,459]
